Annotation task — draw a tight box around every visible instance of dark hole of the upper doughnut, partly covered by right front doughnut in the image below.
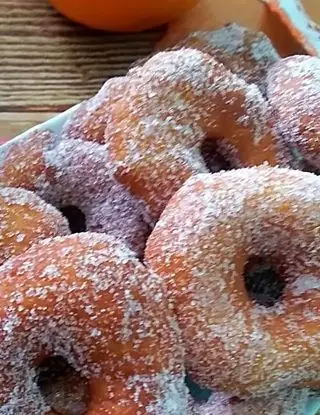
[200,138,232,173]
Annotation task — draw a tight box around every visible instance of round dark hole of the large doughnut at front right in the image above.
[244,257,285,307]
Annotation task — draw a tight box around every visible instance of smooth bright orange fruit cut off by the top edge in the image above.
[50,0,197,32]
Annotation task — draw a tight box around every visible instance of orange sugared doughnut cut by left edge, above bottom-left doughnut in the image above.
[0,187,69,265]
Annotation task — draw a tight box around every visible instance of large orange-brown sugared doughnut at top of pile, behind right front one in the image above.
[105,49,279,217]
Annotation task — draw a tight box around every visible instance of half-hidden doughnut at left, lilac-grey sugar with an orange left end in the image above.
[0,132,153,256]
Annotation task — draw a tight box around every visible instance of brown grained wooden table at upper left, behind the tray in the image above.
[0,0,160,138]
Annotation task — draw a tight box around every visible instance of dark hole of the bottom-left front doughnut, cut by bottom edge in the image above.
[36,356,90,415]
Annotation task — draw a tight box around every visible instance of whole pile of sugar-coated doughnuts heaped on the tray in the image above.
[0,24,320,415]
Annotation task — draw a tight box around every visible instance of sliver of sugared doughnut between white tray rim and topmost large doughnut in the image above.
[62,77,127,144]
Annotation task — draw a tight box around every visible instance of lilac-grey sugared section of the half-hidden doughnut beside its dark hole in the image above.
[43,140,153,256]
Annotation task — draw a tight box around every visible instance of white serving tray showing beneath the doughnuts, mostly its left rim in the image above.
[0,105,320,415]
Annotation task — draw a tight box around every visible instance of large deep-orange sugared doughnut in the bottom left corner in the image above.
[0,233,189,415]
